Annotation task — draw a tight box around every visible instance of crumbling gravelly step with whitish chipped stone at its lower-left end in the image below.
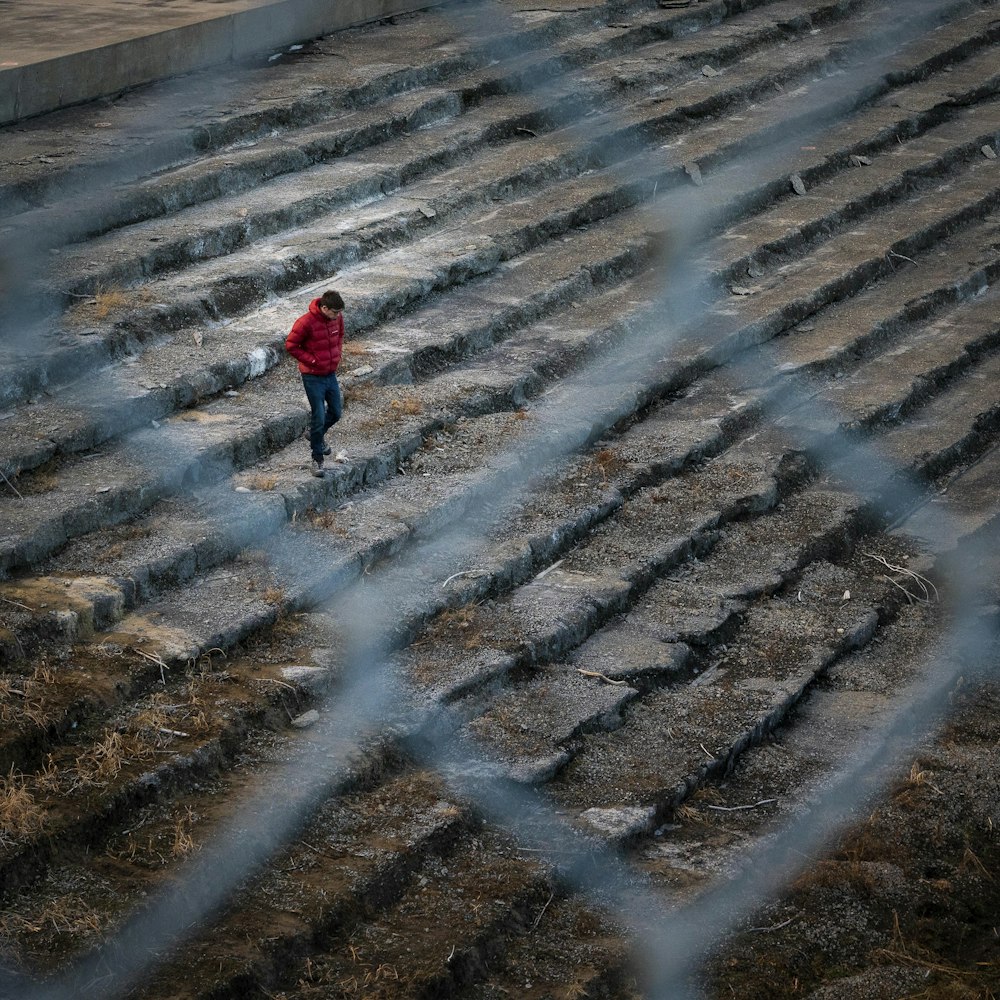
[548,562,885,839]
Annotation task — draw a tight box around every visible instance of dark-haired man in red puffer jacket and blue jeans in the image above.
[285,290,344,476]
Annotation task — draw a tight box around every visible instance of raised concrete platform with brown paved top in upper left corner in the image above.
[0,0,438,124]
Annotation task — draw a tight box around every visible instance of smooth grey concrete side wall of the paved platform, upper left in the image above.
[0,0,441,126]
